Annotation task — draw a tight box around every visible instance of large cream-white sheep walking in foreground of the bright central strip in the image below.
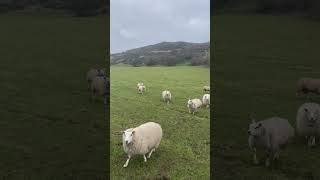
[122,122,162,167]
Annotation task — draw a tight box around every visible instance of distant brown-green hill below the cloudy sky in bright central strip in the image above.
[110,42,210,66]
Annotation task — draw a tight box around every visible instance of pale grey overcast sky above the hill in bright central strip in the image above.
[110,0,210,53]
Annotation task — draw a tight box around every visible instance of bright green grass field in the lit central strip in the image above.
[110,66,210,180]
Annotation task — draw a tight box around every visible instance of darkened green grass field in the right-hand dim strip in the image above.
[212,15,320,180]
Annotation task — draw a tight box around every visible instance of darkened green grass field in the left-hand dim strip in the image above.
[0,14,109,179]
